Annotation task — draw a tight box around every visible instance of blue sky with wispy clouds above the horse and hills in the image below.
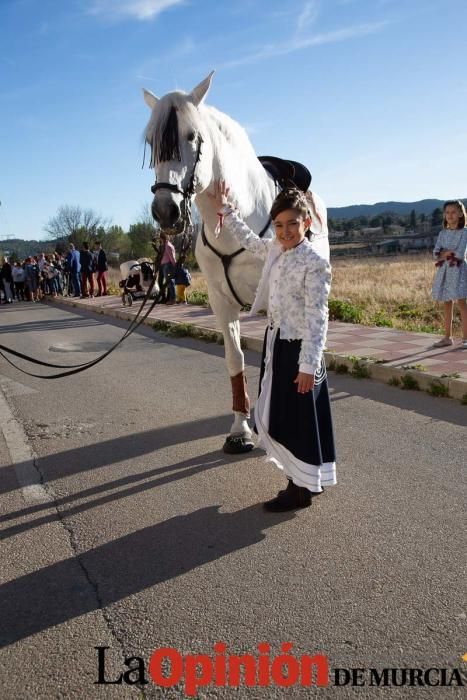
[0,0,467,238]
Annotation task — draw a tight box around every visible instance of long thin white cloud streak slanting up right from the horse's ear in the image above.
[219,22,388,68]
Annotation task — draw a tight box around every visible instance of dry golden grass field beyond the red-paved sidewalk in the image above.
[109,253,460,333]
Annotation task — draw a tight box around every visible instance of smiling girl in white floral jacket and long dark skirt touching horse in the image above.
[212,182,336,512]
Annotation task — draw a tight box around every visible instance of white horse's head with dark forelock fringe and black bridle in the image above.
[144,73,213,233]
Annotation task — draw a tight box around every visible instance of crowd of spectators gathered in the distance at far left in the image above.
[0,241,108,304]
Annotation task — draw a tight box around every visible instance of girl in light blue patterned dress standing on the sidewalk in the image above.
[433,200,467,348]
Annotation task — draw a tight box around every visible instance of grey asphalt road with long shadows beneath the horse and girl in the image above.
[0,304,467,700]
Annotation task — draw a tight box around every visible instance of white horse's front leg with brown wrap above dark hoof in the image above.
[209,288,254,454]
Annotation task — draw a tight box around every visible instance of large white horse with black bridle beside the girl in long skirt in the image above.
[143,72,327,452]
